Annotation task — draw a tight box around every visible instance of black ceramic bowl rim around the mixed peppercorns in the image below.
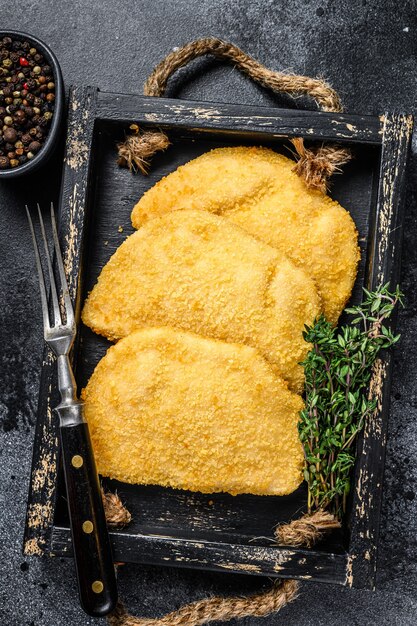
[0,30,64,180]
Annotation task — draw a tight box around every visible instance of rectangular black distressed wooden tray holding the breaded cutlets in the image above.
[24,87,412,587]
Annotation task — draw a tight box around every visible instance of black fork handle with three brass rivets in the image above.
[61,422,117,617]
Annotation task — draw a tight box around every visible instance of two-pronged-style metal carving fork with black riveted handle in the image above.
[26,204,117,617]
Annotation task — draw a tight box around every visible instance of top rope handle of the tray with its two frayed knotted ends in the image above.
[118,37,351,192]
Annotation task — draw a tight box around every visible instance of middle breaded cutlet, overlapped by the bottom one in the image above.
[82,211,320,391]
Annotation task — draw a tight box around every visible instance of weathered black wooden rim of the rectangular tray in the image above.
[24,87,412,588]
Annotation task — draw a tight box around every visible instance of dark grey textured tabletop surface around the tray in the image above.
[0,0,417,626]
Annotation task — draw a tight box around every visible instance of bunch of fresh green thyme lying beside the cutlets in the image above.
[299,284,402,517]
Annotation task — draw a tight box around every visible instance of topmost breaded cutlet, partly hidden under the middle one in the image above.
[132,147,359,324]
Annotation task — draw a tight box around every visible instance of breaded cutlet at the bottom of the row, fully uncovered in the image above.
[83,328,303,495]
